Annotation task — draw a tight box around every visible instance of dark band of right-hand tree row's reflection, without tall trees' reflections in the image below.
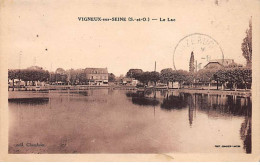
[126,91,252,117]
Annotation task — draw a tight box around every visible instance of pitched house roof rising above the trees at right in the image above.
[204,59,234,69]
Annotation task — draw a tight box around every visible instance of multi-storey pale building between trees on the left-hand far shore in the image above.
[84,68,108,86]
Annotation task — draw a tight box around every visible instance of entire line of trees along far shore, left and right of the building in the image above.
[8,65,252,89]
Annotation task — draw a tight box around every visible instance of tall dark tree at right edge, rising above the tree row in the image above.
[241,19,252,67]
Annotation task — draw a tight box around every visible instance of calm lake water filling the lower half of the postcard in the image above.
[9,89,251,153]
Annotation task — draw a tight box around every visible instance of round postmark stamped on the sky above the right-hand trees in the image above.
[173,33,224,71]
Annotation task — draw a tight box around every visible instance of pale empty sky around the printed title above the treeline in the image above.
[3,0,254,76]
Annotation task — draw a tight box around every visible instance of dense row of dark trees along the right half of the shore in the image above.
[126,65,252,89]
